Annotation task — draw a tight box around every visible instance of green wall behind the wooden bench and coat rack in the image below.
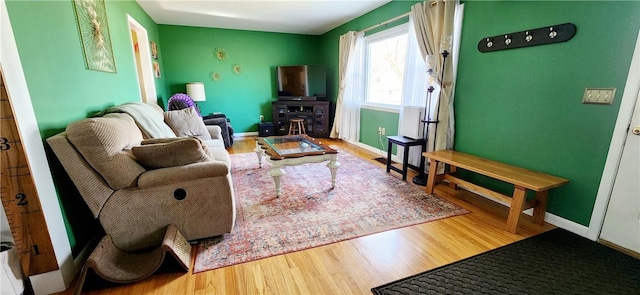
[455,1,640,226]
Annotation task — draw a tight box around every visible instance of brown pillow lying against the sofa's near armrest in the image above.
[131,137,213,169]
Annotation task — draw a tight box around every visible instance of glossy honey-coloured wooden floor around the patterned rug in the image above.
[60,138,553,294]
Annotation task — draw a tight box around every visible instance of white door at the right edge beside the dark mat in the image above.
[600,84,640,253]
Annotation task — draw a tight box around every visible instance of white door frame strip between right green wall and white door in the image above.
[587,30,640,241]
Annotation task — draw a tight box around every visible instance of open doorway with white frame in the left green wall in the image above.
[127,15,158,104]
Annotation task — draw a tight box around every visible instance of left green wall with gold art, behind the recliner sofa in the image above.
[6,0,166,254]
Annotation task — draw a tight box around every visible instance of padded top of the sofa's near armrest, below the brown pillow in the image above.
[138,160,229,189]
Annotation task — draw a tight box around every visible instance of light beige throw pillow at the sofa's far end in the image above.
[164,108,211,140]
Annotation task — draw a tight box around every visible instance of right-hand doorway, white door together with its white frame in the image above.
[587,27,640,257]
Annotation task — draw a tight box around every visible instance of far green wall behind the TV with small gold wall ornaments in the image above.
[158,25,322,132]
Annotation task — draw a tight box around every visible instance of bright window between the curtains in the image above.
[365,24,409,108]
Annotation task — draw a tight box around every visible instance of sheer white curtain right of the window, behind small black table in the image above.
[398,16,433,166]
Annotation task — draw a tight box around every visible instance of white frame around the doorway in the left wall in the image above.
[127,14,158,104]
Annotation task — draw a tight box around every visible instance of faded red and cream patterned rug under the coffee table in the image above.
[193,151,468,273]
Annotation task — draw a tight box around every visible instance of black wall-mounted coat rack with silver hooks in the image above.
[478,23,576,52]
